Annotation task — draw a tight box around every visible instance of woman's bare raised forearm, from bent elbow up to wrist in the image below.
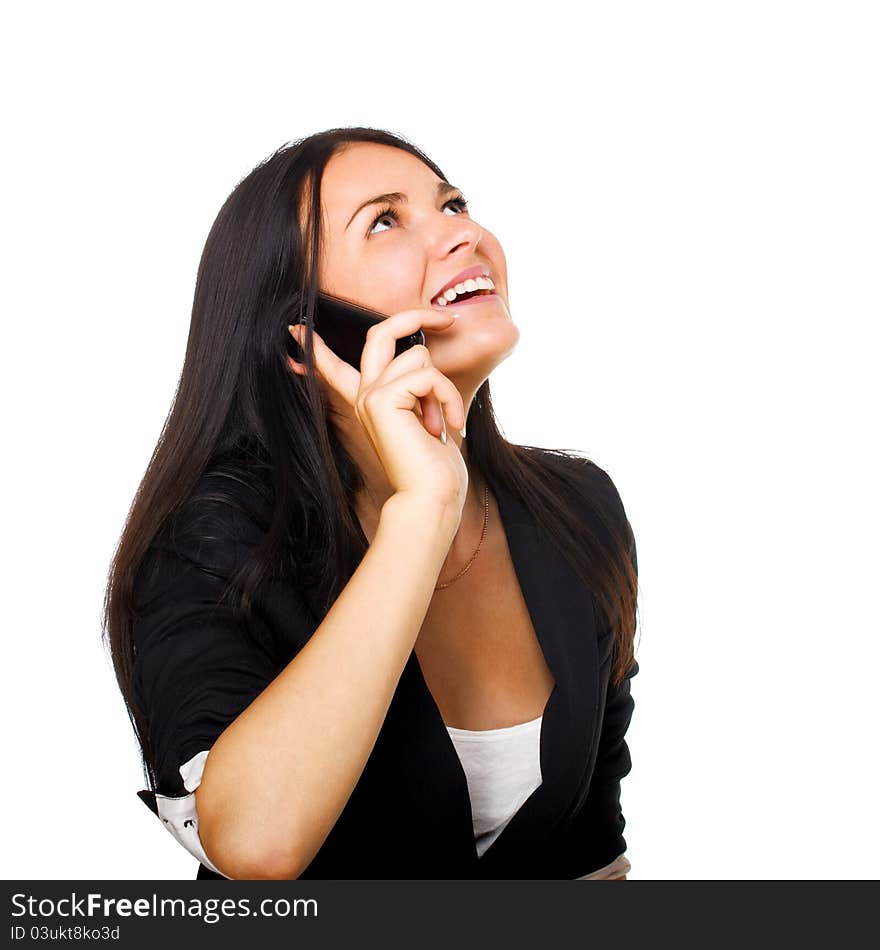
[196,493,458,878]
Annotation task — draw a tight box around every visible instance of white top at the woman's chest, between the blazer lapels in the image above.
[446,716,544,857]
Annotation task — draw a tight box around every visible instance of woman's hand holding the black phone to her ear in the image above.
[288,308,468,516]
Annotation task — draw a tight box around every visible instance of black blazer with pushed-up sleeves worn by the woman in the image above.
[135,450,638,879]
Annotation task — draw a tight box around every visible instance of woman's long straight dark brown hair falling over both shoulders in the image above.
[102,127,637,787]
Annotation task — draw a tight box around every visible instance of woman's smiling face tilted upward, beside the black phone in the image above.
[318,142,519,384]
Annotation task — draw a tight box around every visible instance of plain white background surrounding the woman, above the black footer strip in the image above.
[0,0,880,880]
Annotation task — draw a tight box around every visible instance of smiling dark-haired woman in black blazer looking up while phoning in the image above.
[105,128,638,879]
